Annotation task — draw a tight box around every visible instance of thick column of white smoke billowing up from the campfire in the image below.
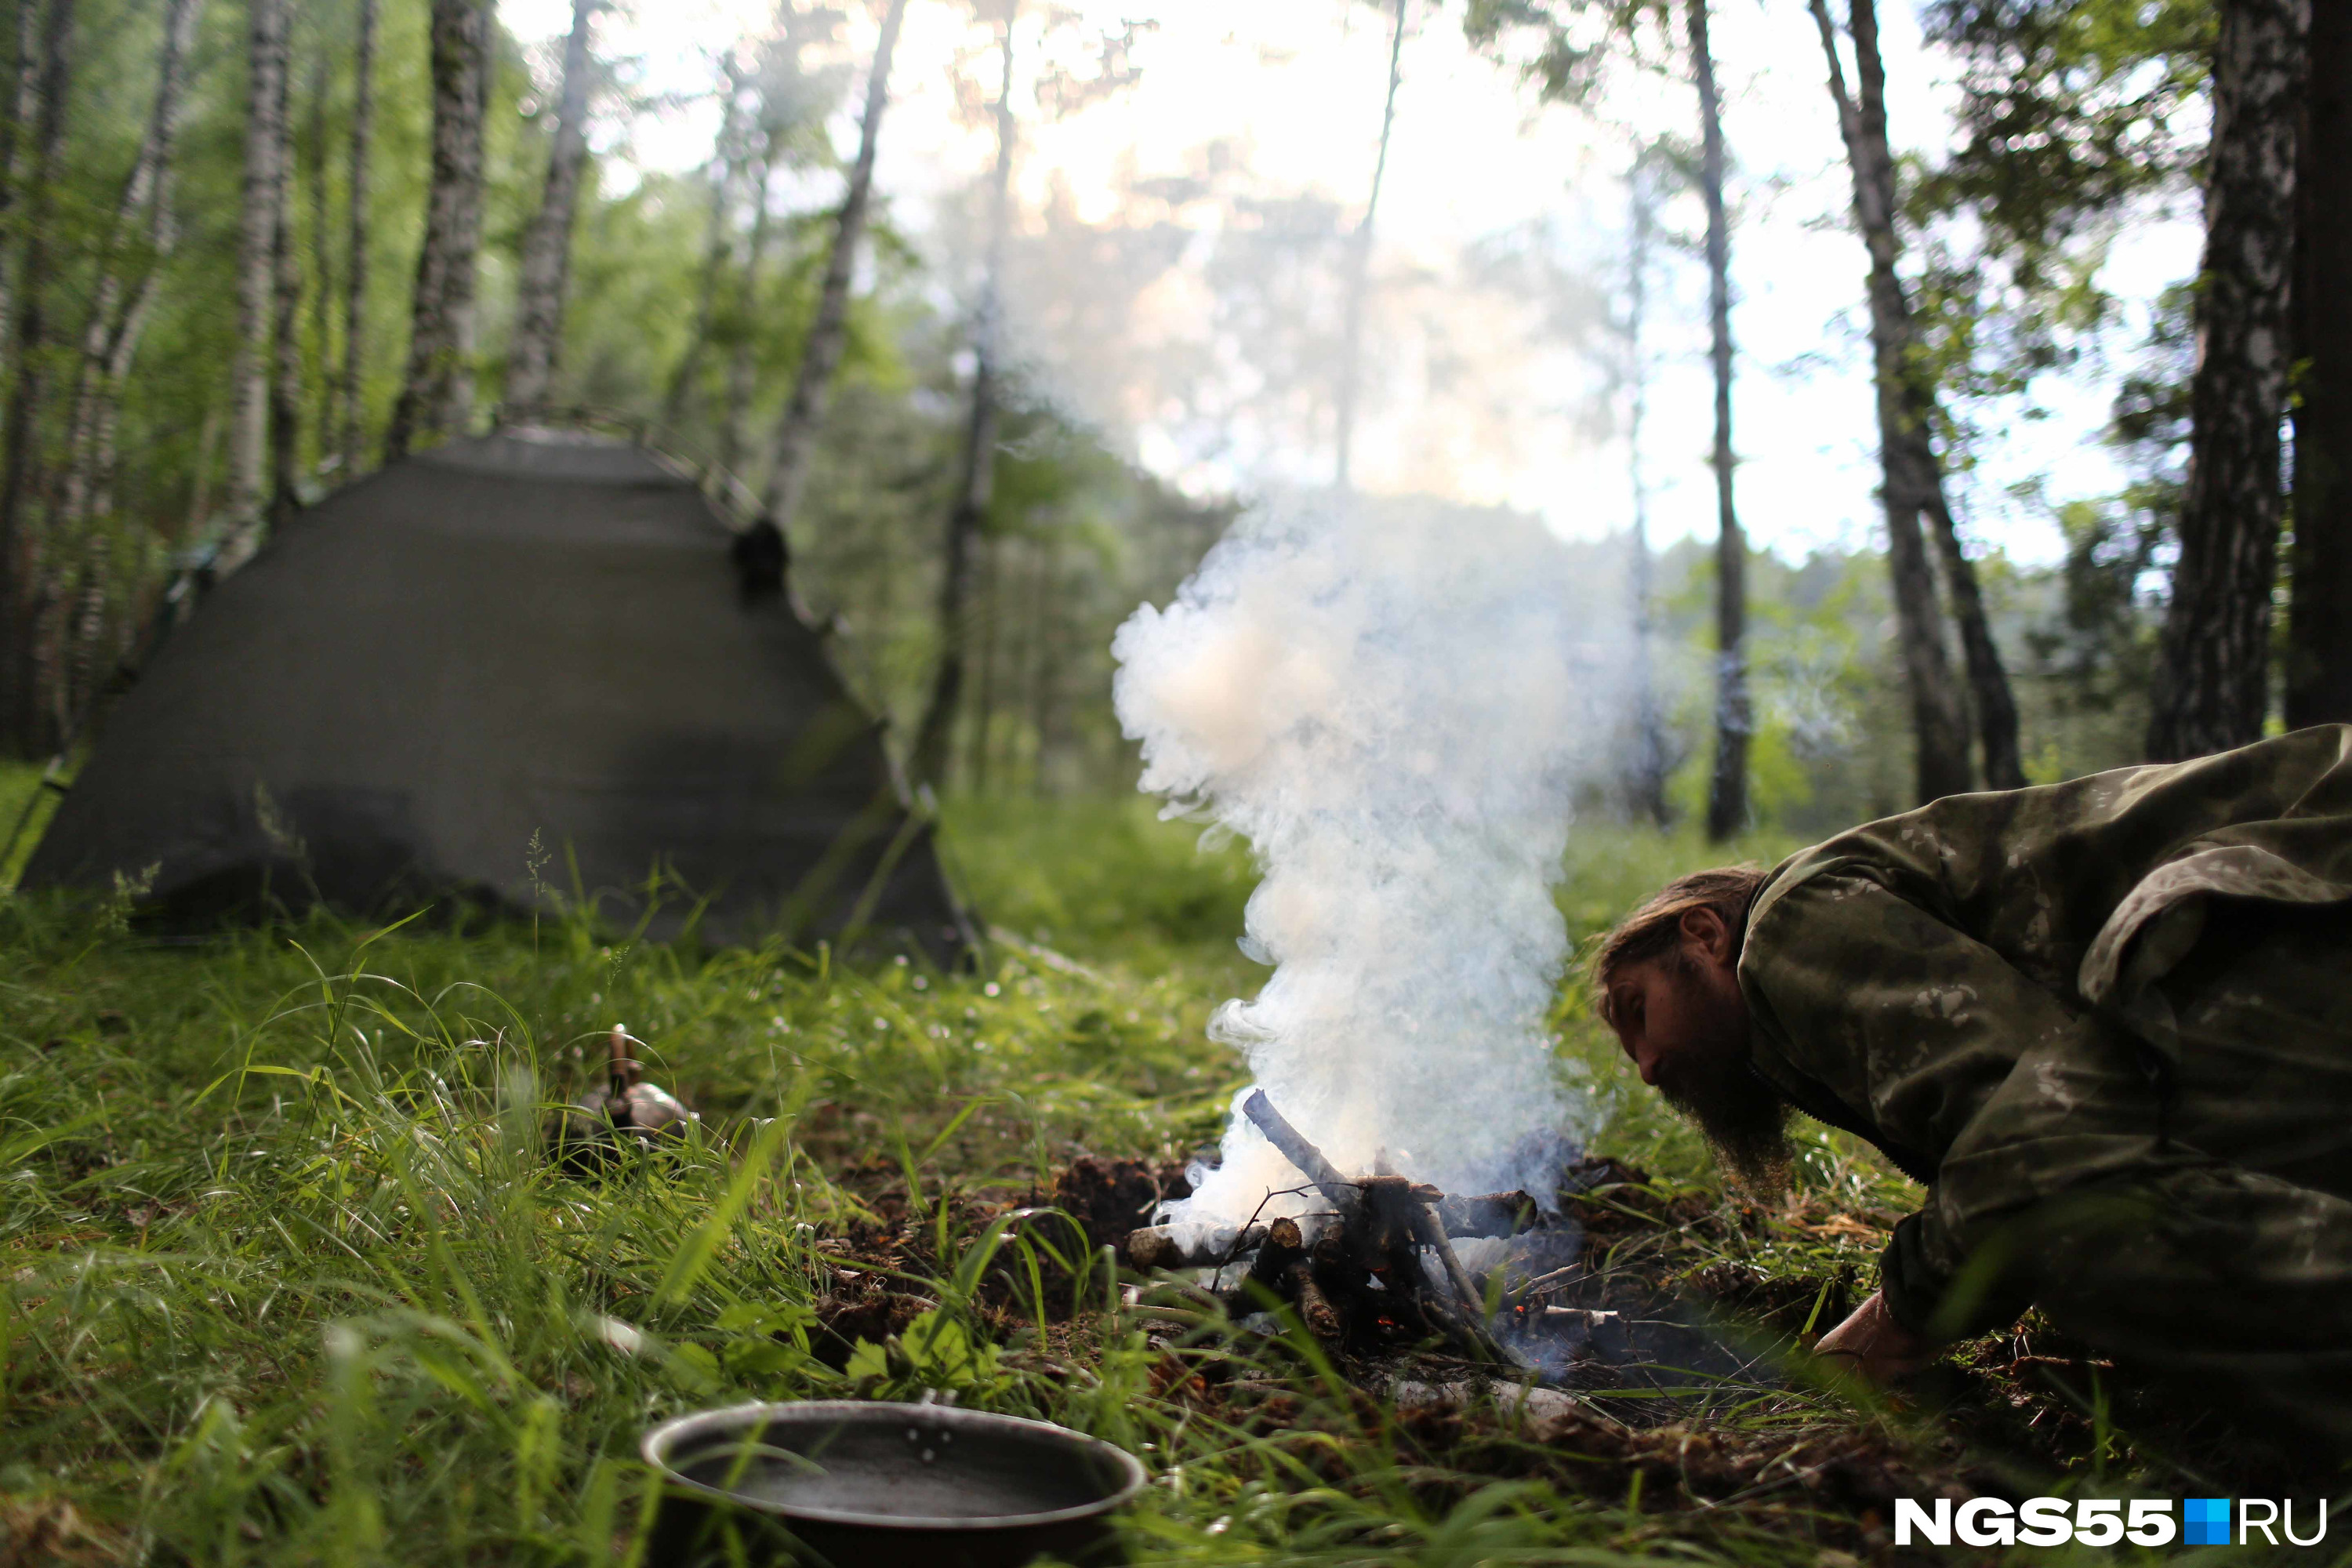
[1112,496,1623,1229]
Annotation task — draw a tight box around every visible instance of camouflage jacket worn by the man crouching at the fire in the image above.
[1738,727,2352,1330]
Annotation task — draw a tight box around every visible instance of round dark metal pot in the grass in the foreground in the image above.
[640,1399,1143,1568]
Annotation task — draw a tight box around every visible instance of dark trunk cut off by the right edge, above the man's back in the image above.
[2286,5,2352,729]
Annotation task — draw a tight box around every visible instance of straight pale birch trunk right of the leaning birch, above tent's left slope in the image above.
[228,0,287,533]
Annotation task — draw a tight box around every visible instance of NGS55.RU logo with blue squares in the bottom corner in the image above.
[1896,1497,2328,1547]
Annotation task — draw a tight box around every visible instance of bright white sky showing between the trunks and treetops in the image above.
[501,0,2199,562]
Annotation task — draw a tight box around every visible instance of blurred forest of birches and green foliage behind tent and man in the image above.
[0,0,2352,837]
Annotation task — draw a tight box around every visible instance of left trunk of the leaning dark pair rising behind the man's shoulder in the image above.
[1811,0,1973,804]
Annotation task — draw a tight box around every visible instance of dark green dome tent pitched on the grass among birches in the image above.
[21,428,969,959]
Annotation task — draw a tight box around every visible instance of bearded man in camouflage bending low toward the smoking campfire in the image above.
[1592,727,2352,1453]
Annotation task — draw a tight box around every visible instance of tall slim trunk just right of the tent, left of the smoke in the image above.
[913,7,1014,789]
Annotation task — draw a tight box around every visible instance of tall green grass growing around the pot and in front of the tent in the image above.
[0,804,1919,1563]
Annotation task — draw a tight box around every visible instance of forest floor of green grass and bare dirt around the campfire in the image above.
[0,804,2314,1568]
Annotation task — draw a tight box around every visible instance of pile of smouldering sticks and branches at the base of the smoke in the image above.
[1127,1091,1541,1361]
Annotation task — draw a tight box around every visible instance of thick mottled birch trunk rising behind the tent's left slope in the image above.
[383,0,489,459]
